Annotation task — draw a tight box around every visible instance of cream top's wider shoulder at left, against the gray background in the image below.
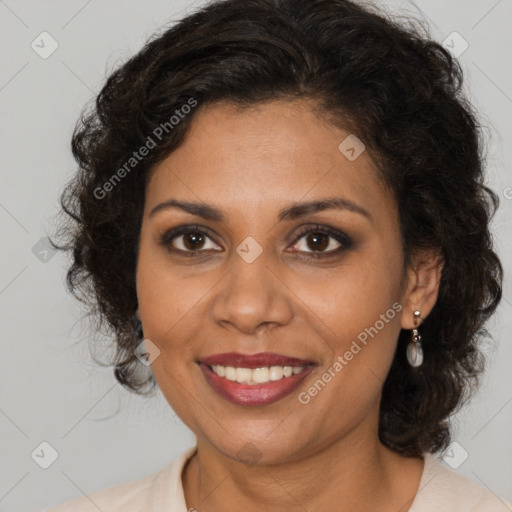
[42,447,195,512]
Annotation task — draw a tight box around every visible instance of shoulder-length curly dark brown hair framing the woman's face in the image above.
[55,0,503,456]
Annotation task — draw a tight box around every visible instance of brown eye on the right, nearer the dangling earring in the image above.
[293,226,352,257]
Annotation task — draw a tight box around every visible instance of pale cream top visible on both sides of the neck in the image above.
[42,446,512,512]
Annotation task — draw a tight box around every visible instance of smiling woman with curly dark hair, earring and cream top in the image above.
[50,0,508,512]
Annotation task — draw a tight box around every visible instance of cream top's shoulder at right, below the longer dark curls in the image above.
[409,453,512,512]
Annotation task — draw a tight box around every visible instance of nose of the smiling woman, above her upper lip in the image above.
[212,251,293,334]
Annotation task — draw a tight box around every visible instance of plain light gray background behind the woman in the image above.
[0,0,512,511]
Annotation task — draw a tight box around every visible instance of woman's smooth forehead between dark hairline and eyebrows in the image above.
[146,101,394,225]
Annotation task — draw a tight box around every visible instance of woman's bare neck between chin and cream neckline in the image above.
[182,422,423,512]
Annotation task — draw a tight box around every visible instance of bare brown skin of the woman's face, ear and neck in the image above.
[137,100,441,512]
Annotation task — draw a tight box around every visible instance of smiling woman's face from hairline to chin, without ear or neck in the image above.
[137,102,420,463]
